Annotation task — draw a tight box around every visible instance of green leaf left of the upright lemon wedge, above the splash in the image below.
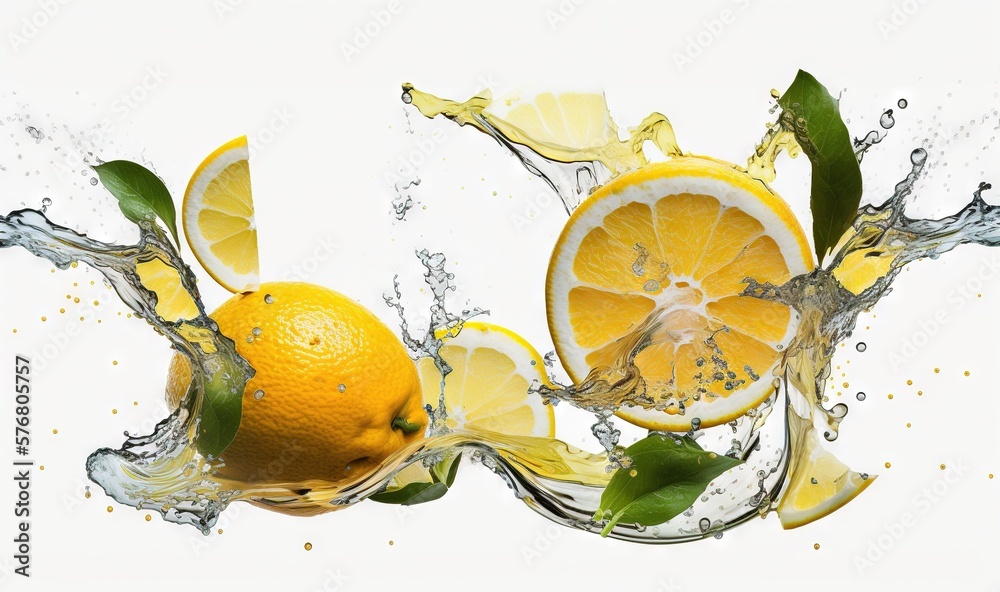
[93,160,180,249]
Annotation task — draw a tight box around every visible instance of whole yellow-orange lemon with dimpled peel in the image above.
[166,282,427,483]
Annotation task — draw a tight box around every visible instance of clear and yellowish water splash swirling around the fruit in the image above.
[0,81,1000,543]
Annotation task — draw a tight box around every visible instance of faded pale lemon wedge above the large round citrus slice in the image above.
[484,92,618,150]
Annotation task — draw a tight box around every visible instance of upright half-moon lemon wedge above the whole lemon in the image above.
[181,136,260,292]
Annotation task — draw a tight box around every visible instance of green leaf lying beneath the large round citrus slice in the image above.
[594,435,742,536]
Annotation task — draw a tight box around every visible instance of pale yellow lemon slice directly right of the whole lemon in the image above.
[417,322,555,437]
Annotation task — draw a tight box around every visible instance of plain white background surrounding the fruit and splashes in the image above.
[0,0,1000,592]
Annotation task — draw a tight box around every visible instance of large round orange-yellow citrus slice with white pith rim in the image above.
[546,157,813,431]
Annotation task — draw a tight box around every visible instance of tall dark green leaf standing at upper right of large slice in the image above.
[778,70,861,265]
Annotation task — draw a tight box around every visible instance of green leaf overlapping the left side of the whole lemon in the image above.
[196,358,246,458]
